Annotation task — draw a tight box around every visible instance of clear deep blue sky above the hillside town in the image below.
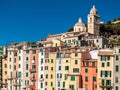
[0,0,120,45]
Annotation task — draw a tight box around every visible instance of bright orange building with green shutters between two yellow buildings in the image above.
[80,52,97,90]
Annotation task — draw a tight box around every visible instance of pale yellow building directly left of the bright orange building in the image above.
[62,52,81,90]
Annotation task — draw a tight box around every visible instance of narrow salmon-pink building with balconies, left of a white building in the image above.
[29,45,39,90]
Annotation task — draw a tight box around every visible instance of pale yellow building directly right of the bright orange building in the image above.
[97,49,114,90]
